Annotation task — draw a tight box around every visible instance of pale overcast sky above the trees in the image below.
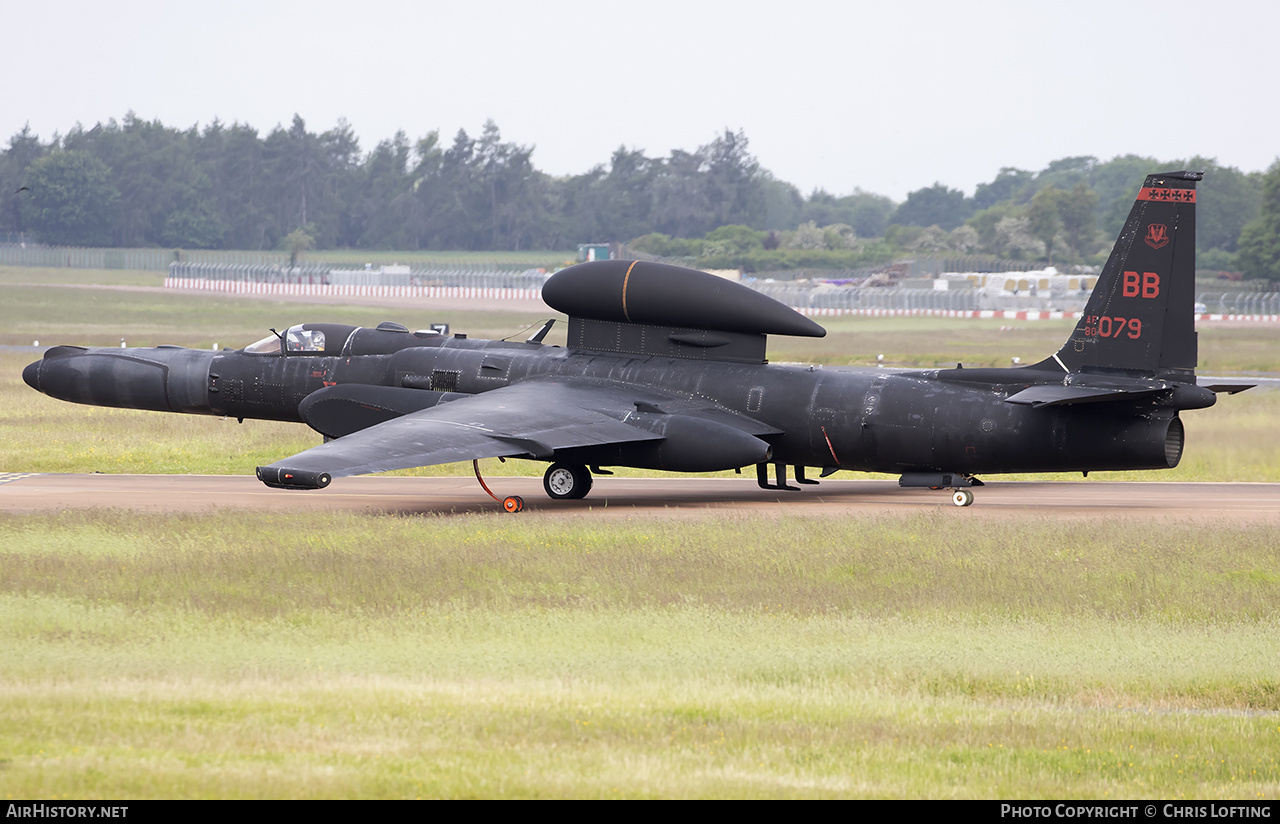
[0,0,1280,200]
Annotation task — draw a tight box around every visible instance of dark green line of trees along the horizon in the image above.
[0,113,1280,279]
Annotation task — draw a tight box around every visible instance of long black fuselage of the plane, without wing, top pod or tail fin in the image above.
[24,330,1198,475]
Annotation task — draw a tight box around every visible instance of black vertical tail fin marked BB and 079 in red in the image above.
[1043,171,1204,380]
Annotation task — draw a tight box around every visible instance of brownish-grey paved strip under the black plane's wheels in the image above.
[0,473,1280,525]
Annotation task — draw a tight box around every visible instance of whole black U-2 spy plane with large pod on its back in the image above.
[23,171,1248,512]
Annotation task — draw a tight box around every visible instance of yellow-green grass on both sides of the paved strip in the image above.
[0,271,1280,800]
